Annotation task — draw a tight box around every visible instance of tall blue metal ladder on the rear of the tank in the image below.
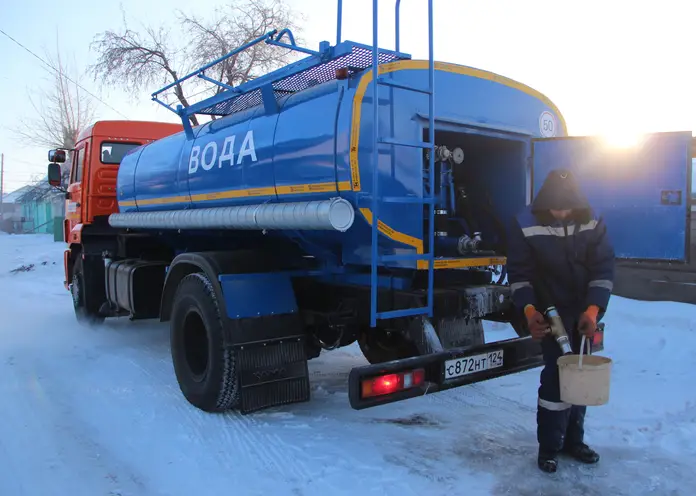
[370,0,435,327]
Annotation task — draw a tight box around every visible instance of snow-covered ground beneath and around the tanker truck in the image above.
[0,235,696,496]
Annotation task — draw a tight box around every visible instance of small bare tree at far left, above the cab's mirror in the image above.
[16,50,94,154]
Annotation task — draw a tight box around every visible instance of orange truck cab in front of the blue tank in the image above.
[48,121,183,288]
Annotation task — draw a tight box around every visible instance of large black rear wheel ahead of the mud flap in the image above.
[170,273,239,412]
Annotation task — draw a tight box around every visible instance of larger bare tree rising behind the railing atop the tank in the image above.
[89,0,301,125]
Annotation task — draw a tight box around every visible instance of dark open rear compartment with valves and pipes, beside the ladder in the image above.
[424,130,530,264]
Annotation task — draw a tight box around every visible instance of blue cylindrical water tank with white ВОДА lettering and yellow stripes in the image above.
[115,60,566,266]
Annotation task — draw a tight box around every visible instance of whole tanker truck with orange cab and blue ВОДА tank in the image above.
[44,1,691,413]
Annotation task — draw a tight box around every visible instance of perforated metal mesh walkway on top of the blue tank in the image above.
[198,46,399,116]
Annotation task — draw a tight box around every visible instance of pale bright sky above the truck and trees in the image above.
[0,0,696,191]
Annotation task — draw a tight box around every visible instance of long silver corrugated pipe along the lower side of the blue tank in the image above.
[109,198,355,232]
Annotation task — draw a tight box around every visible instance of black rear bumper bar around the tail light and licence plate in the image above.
[348,337,544,410]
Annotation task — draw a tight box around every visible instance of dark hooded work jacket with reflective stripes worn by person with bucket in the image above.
[507,169,614,318]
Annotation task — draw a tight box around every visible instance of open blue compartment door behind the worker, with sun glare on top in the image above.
[532,132,693,262]
